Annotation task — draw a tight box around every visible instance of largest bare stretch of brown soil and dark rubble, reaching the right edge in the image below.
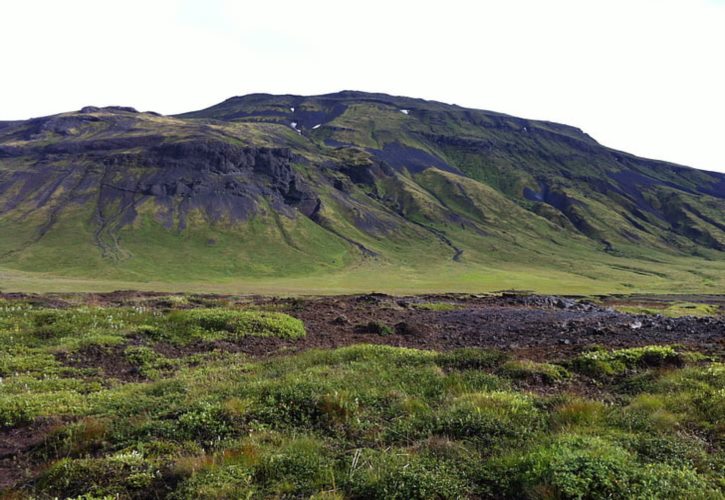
[238,295,725,359]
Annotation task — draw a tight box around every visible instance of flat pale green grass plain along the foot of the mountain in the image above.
[0,250,725,295]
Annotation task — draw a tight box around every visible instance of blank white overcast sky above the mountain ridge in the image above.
[0,0,725,172]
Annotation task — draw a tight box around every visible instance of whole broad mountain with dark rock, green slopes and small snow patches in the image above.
[0,91,725,292]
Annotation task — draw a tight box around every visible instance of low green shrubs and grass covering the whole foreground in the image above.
[0,297,725,499]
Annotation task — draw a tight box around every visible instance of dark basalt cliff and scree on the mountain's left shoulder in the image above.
[0,136,322,239]
